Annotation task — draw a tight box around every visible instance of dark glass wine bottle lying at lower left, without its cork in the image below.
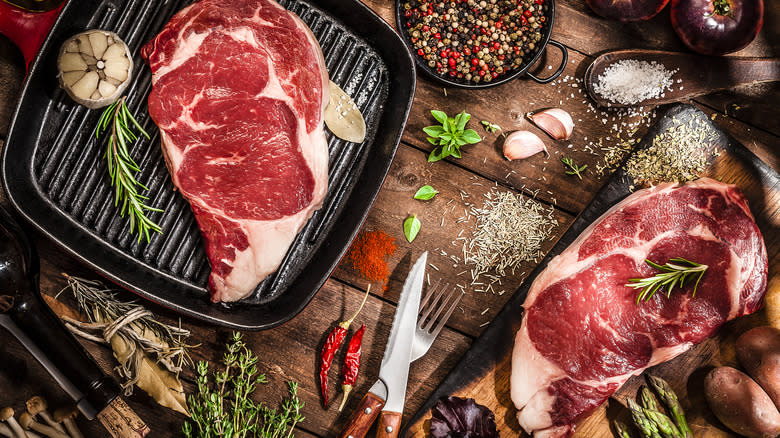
[0,207,119,420]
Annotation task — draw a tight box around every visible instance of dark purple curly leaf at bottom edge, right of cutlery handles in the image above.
[431,396,499,438]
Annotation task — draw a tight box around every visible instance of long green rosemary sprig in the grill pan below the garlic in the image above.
[95,96,162,242]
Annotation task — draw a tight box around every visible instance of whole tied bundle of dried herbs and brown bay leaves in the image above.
[57,274,192,414]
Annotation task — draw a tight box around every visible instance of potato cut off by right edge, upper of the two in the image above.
[736,326,780,409]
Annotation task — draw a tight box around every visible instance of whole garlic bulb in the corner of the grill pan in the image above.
[57,30,133,109]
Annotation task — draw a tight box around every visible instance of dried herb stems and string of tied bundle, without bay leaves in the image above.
[57,274,194,384]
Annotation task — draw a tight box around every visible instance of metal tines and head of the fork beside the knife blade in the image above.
[412,279,465,362]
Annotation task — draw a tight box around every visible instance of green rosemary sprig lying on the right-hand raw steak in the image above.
[626,257,708,304]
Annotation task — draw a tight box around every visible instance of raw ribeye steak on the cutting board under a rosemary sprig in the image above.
[511,178,768,438]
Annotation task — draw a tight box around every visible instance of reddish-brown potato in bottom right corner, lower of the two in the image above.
[704,367,780,438]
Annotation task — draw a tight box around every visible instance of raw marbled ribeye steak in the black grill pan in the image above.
[141,0,328,302]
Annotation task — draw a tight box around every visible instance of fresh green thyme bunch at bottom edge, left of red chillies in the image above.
[182,332,304,438]
